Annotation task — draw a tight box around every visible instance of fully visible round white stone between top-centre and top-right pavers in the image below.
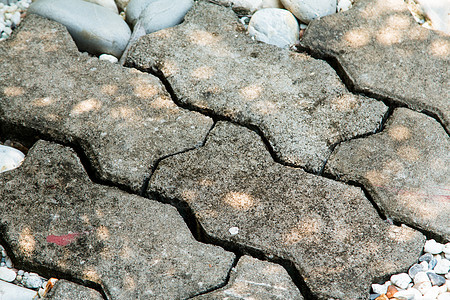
[248,8,300,48]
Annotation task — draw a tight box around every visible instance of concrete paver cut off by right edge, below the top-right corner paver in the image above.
[325,108,450,241]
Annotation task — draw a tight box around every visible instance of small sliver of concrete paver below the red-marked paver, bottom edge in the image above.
[44,279,103,300]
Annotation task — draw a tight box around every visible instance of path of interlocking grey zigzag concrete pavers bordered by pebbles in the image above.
[0,0,450,299]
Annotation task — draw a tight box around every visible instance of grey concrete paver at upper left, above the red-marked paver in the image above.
[0,15,213,191]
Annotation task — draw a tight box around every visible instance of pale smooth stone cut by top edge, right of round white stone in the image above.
[281,0,336,24]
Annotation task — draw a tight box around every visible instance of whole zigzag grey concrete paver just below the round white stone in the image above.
[127,1,387,172]
